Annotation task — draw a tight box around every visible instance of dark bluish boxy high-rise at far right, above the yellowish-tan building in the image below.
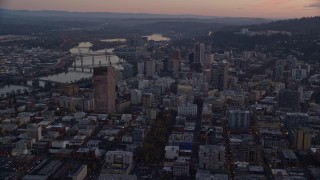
[278,89,300,111]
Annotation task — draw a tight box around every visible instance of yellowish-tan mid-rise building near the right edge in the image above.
[296,127,311,150]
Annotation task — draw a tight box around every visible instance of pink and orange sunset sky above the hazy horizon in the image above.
[0,0,320,19]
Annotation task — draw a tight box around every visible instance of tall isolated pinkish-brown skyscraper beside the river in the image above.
[92,66,116,113]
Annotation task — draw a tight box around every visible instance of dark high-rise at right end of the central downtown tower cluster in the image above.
[211,60,229,91]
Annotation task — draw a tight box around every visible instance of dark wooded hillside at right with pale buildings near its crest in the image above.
[209,17,320,62]
